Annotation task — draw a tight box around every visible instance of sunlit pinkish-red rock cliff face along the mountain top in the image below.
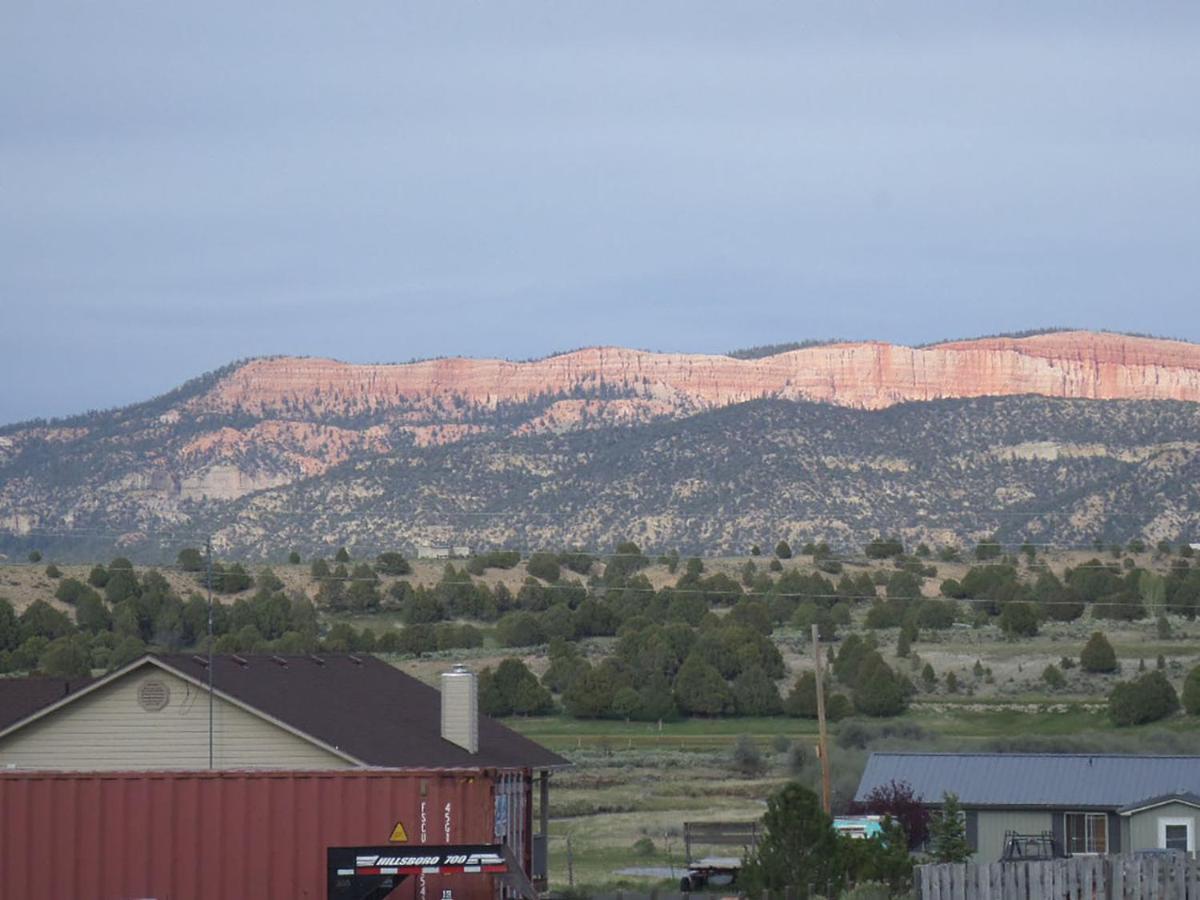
[191,331,1200,427]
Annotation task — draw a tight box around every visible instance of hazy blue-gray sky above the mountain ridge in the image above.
[0,0,1200,424]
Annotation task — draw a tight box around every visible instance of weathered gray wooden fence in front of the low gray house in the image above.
[913,856,1200,900]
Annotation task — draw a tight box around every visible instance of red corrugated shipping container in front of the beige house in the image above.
[0,770,528,900]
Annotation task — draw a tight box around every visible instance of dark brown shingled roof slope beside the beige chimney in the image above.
[154,654,569,769]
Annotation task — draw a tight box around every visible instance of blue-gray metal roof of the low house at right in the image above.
[854,754,1200,810]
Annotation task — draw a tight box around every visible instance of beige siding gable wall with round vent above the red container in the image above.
[0,666,352,770]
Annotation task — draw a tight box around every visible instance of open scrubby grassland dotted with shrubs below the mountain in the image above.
[0,551,1200,888]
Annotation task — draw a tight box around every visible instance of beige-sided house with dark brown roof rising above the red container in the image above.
[0,654,568,772]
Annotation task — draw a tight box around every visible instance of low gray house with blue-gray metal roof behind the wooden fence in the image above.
[854,752,1200,862]
